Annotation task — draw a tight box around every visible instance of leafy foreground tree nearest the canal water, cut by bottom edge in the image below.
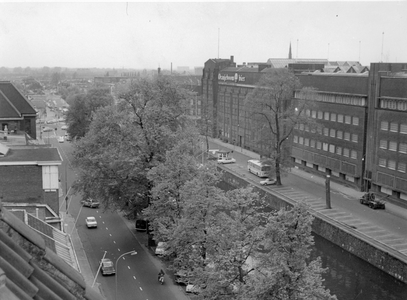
[240,203,336,300]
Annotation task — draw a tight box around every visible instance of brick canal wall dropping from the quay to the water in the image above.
[220,168,407,283]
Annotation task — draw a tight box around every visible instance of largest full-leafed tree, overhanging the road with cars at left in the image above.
[74,78,190,215]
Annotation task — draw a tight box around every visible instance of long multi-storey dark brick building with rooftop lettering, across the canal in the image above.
[202,57,407,206]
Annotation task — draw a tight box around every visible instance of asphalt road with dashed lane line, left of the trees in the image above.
[47,102,188,300]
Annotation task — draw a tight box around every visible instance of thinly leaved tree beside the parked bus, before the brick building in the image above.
[245,69,314,185]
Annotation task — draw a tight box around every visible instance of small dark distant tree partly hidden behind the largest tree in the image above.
[66,89,113,138]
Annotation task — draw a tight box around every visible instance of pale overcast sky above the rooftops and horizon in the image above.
[0,0,407,69]
